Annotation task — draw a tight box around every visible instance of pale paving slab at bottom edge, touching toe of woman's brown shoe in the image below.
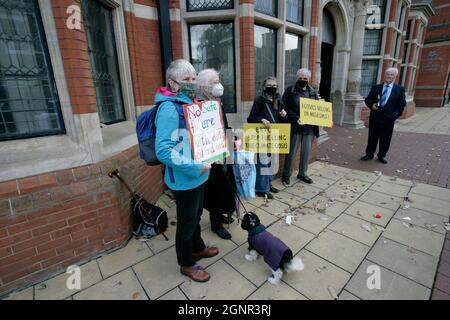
[180,260,256,300]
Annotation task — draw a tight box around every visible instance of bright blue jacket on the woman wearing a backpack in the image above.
[155,88,209,191]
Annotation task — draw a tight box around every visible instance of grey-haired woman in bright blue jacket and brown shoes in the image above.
[155,59,219,282]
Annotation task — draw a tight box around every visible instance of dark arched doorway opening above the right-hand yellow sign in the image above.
[319,8,336,101]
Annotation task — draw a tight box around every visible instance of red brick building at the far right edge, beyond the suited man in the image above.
[414,0,450,107]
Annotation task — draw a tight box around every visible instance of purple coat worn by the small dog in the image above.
[248,230,290,270]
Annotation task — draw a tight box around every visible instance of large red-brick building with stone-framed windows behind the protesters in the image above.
[0,0,433,295]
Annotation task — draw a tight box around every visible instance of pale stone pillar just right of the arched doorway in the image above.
[342,0,369,129]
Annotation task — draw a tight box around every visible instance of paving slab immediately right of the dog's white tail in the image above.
[306,230,370,273]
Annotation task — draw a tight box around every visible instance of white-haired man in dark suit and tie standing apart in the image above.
[361,68,406,163]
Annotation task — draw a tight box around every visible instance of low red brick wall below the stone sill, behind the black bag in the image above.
[0,147,163,295]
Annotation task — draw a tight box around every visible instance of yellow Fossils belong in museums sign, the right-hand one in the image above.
[300,98,333,128]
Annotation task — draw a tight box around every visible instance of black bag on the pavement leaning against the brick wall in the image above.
[131,195,168,238]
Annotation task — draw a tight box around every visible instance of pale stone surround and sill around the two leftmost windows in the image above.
[0,0,137,181]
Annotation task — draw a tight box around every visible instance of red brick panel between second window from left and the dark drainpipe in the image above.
[125,9,164,106]
